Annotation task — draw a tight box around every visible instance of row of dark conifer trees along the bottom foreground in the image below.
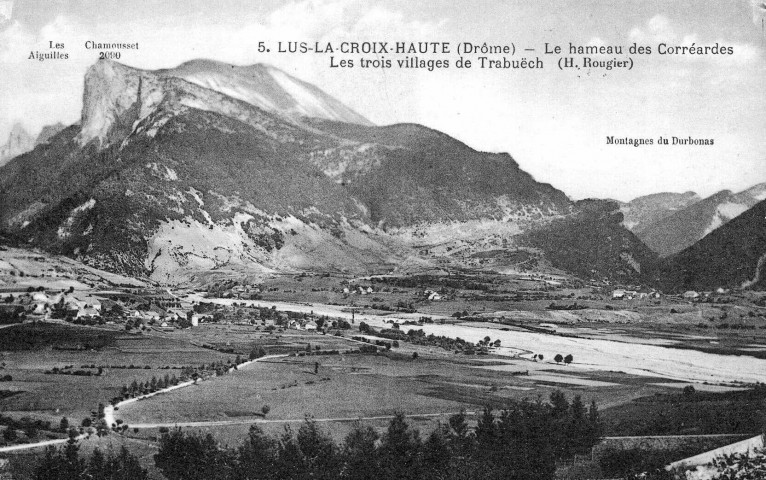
[28,391,601,480]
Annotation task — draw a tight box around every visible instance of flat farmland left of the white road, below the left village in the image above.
[0,324,234,424]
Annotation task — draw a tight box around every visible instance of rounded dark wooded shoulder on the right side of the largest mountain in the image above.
[309,122,571,227]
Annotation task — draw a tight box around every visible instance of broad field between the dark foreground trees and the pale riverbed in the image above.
[118,344,680,427]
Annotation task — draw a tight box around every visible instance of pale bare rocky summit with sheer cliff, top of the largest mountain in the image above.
[77,60,372,146]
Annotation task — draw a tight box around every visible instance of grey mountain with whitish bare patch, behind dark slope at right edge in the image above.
[634,183,766,257]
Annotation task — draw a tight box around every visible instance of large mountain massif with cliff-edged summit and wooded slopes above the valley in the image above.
[0,61,651,283]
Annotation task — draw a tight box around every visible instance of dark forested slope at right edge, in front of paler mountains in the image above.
[661,201,766,292]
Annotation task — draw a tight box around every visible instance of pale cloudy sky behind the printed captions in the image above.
[0,0,766,201]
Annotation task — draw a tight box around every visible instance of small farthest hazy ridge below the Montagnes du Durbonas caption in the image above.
[620,192,701,232]
